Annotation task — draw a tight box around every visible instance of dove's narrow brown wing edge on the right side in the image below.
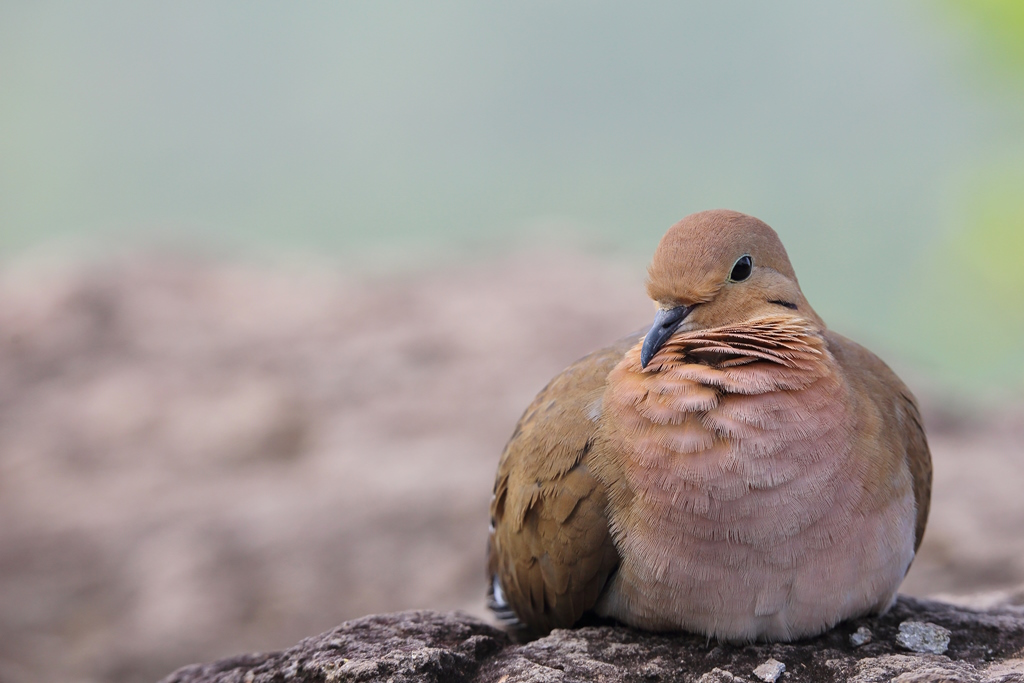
[825,331,932,552]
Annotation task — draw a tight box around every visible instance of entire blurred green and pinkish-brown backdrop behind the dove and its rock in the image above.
[0,0,1024,683]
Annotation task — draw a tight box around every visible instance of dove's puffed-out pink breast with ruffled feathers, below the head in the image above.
[595,319,913,640]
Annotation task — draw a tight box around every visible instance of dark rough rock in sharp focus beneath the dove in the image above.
[164,597,1024,683]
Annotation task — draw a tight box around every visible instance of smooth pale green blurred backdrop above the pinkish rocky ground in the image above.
[0,0,1024,393]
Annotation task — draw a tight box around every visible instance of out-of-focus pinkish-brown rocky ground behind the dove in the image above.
[0,252,1024,683]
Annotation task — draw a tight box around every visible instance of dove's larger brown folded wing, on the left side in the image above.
[487,332,643,634]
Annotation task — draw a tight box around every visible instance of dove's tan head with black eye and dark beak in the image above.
[640,210,824,367]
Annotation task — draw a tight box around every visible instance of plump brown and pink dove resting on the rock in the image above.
[487,210,932,642]
